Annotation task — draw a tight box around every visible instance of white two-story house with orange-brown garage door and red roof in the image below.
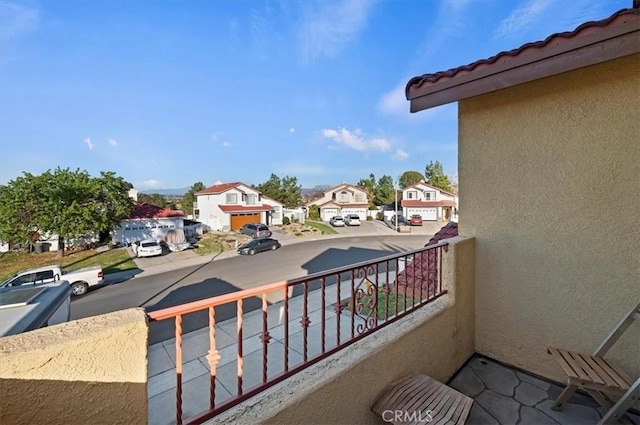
[194,182,284,231]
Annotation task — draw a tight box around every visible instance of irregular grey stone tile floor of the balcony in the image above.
[449,355,640,425]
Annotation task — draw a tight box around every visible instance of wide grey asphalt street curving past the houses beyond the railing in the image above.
[71,235,428,343]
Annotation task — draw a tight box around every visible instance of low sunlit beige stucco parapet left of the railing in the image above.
[0,309,148,425]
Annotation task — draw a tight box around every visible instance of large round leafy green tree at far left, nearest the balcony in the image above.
[0,168,135,257]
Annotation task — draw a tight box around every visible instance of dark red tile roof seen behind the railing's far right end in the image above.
[394,222,458,296]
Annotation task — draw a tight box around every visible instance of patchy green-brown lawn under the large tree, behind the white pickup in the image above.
[0,248,136,281]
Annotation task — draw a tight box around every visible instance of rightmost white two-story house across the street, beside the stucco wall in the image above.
[400,182,458,221]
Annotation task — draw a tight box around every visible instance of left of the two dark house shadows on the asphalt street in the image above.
[146,278,262,345]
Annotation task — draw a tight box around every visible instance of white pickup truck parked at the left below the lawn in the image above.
[0,266,104,296]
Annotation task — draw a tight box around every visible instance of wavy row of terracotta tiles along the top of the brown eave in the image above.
[405,9,638,94]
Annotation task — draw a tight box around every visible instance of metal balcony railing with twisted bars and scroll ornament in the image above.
[148,242,448,424]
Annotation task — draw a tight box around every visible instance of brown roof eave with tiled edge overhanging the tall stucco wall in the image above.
[405,8,640,112]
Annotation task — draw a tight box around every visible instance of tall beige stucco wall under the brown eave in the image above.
[459,55,640,379]
